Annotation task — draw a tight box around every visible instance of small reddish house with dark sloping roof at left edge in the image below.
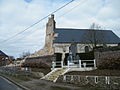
[0,50,9,66]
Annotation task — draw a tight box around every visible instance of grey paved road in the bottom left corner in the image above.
[0,76,22,90]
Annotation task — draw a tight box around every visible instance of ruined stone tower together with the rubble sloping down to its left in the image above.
[30,14,55,57]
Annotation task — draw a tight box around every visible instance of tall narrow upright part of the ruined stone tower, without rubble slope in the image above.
[45,14,55,54]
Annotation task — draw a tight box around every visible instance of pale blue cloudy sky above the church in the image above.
[0,0,120,57]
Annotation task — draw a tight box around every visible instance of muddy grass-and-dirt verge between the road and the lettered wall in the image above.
[4,75,103,90]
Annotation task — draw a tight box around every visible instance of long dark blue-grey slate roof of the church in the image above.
[53,28,120,44]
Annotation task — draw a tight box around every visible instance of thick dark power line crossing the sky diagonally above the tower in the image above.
[1,0,75,43]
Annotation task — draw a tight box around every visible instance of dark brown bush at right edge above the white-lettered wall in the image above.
[98,56,120,70]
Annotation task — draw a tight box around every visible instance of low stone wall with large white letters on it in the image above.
[57,75,120,90]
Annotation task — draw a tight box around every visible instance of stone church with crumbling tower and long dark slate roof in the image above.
[30,15,120,65]
